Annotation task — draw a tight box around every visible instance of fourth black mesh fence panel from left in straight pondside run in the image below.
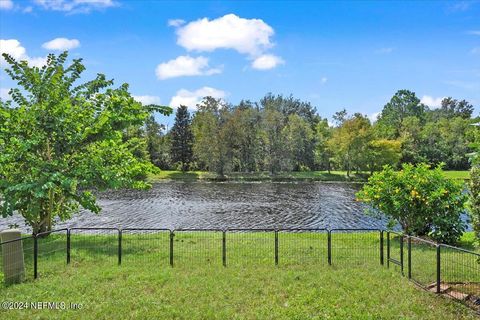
[226,229,275,265]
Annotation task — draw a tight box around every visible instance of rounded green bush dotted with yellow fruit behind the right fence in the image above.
[357,164,467,244]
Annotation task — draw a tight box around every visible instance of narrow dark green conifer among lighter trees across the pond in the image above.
[170,106,193,171]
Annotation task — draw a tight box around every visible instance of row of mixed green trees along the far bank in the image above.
[141,90,478,176]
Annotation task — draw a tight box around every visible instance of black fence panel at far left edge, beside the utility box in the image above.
[0,236,34,285]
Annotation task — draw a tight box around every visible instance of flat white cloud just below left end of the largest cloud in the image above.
[155,56,222,80]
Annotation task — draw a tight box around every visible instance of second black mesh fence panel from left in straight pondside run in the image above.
[122,228,170,266]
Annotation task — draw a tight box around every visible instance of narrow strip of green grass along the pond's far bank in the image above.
[149,170,469,182]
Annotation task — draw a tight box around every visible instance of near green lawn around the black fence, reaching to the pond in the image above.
[0,232,476,319]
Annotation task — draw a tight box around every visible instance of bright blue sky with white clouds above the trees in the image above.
[0,0,480,124]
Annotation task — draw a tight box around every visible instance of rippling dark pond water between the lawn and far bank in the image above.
[0,181,386,231]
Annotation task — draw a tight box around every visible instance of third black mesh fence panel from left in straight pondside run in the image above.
[173,229,223,266]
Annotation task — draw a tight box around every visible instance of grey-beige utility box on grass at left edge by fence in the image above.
[0,229,25,285]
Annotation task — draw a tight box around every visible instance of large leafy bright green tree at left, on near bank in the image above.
[0,52,171,233]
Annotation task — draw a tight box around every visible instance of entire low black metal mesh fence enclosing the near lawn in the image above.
[0,228,480,305]
